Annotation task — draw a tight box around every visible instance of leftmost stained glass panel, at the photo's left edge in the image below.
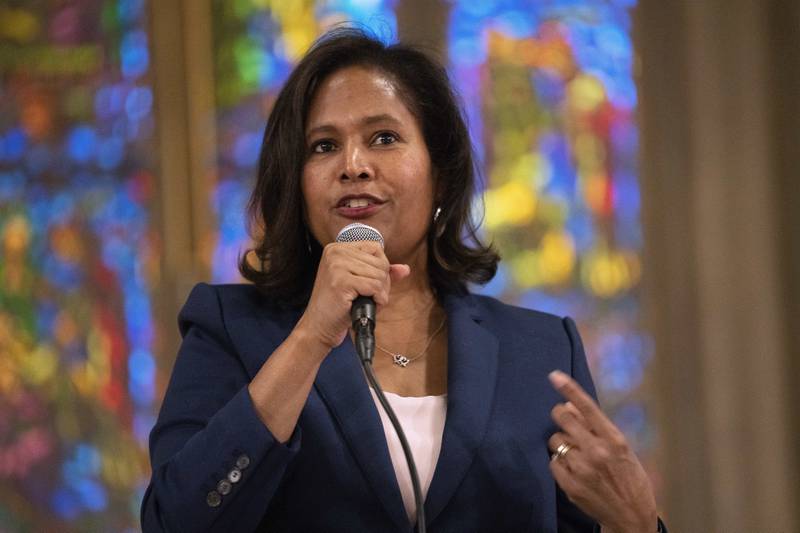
[0,0,159,531]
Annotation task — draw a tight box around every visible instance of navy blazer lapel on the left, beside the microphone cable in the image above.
[315,336,411,531]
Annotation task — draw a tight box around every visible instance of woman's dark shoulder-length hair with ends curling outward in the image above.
[239,28,500,305]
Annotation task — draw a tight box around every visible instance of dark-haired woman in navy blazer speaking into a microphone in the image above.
[142,30,660,532]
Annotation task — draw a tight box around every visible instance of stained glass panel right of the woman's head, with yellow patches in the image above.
[448,0,657,479]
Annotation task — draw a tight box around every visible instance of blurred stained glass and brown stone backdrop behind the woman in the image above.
[0,0,800,532]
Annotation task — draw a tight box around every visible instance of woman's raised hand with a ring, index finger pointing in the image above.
[548,371,658,533]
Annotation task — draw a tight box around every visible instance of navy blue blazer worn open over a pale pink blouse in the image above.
[141,284,595,533]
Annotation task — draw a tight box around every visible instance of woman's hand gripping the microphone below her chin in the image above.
[296,241,410,353]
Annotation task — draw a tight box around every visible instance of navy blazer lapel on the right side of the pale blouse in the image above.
[425,295,499,524]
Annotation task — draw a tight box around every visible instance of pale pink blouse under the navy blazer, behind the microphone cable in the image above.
[369,387,447,523]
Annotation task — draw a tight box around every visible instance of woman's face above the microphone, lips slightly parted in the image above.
[302,67,434,264]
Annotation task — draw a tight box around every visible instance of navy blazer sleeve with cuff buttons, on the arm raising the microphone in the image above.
[141,284,301,533]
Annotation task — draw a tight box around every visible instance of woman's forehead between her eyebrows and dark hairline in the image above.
[306,67,416,130]
